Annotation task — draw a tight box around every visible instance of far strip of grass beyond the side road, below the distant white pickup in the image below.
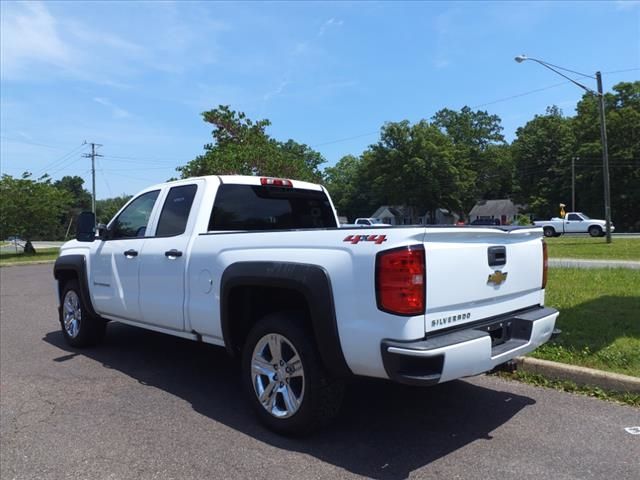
[545,236,640,260]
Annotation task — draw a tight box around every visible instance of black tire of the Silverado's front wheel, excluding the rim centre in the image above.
[60,279,107,348]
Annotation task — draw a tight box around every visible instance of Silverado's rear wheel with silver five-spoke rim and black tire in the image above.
[242,314,344,435]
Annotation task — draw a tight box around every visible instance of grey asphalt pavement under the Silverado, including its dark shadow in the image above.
[0,265,640,480]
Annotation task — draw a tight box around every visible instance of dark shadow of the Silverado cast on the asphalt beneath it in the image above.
[44,323,535,479]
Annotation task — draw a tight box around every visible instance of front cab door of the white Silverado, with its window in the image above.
[89,190,160,320]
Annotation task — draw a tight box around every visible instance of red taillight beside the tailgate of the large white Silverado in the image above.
[376,245,425,315]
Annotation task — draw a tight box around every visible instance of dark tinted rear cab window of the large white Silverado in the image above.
[208,184,338,231]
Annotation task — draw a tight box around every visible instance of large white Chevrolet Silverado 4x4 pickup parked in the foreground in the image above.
[54,176,558,433]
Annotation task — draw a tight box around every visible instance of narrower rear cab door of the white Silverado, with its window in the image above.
[140,183,198,331]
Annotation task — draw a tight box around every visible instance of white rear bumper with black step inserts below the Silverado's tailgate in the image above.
[381,307,558,385]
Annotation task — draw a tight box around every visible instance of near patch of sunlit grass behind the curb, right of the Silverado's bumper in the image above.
[532,268,640,377]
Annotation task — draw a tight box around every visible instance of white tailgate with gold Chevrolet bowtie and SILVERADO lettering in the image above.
[425,227,544,332]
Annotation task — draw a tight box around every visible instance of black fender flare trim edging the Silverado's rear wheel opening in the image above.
[220,261,351,377]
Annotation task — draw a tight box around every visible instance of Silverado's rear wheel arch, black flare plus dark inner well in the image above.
[220,261,351,376]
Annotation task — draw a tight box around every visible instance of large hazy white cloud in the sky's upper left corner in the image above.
[0,2,229,84]
